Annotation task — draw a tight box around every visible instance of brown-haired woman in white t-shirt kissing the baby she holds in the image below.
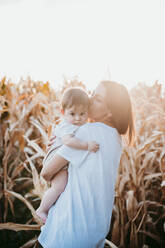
[39,81,134,248]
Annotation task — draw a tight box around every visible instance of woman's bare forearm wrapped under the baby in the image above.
[41,154,68,181]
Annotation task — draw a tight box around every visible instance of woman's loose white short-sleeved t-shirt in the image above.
[38,122,122,248]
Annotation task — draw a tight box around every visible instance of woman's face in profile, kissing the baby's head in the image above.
[89,84,110,122]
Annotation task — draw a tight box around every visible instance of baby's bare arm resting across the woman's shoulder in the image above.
[62,134,99,152]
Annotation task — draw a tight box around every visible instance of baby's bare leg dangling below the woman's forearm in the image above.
[36,169,68,222]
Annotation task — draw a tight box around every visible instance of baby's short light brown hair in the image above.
[61,87,89,110]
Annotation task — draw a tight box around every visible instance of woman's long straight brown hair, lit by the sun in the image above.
[101,80,135,144]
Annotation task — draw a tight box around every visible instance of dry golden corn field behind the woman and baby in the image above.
[0,77,165,248]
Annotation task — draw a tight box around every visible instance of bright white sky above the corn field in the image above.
[0,0,165,89]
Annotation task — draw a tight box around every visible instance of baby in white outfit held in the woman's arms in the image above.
[36,88,99,222]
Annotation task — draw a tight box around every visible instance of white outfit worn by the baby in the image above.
[43,119,79,166]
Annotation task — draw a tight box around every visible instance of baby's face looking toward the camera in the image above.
[64,105,88,126]
